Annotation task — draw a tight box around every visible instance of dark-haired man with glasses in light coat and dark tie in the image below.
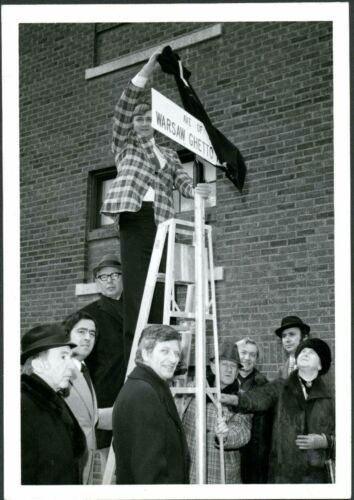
[64,311,112,484]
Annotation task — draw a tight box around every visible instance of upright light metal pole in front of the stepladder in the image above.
[194,189,206,484]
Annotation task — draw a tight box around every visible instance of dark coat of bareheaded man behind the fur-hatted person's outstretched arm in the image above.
[238,369,273,484]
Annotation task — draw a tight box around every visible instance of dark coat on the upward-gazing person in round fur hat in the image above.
[238,370,335,484]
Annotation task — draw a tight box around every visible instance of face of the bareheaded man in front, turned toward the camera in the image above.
[142,340,181,380]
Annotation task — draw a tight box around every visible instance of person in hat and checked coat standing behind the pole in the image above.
[183,342,252,484]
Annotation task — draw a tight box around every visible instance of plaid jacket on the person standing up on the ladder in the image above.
[101,82,193,224]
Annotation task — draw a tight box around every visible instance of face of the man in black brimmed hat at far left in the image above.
[35,346,74,391]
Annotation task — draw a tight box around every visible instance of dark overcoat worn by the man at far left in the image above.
[21,374,86,485]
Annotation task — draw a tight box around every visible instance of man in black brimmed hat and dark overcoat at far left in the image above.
[21,324,86,485]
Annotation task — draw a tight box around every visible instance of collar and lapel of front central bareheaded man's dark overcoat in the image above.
[128,362,181,427]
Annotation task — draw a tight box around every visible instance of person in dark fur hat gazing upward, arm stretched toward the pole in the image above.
[222,338,335,484]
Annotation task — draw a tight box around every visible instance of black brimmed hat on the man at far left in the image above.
[21,323,76,364]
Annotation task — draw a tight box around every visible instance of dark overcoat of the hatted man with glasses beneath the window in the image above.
[83,295,126,448]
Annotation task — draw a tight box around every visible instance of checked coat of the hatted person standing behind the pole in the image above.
[182,398,252,484]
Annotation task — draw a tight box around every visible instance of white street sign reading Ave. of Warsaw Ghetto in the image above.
[151,89,219,165]
